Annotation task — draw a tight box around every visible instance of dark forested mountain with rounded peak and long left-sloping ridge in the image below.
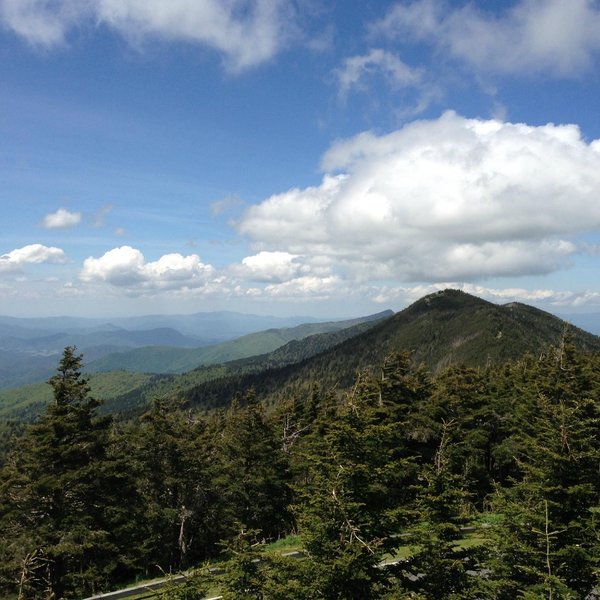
[180,289,600,407]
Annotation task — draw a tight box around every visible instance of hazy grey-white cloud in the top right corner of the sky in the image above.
[372,0,600,77]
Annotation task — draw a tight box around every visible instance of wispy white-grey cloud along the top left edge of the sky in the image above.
[0,0,294,71]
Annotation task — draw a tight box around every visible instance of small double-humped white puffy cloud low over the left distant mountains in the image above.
[80,246,215,291]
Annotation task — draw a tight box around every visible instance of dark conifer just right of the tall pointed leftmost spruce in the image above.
[123,398,216,572]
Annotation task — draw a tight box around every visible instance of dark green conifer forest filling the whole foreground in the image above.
[0,333,600,600]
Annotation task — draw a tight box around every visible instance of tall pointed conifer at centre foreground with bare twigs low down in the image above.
[296,373,415,600]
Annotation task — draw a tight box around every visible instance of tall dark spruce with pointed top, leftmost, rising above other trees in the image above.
[0,347,136,599]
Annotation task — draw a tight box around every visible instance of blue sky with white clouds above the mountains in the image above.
[0,0,600,318]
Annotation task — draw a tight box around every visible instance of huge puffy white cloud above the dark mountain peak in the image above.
[237,112,600,282]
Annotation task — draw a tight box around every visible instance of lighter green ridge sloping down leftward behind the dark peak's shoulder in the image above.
[87,310,394,373]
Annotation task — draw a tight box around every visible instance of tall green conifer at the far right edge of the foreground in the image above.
[491,345,600,598]
